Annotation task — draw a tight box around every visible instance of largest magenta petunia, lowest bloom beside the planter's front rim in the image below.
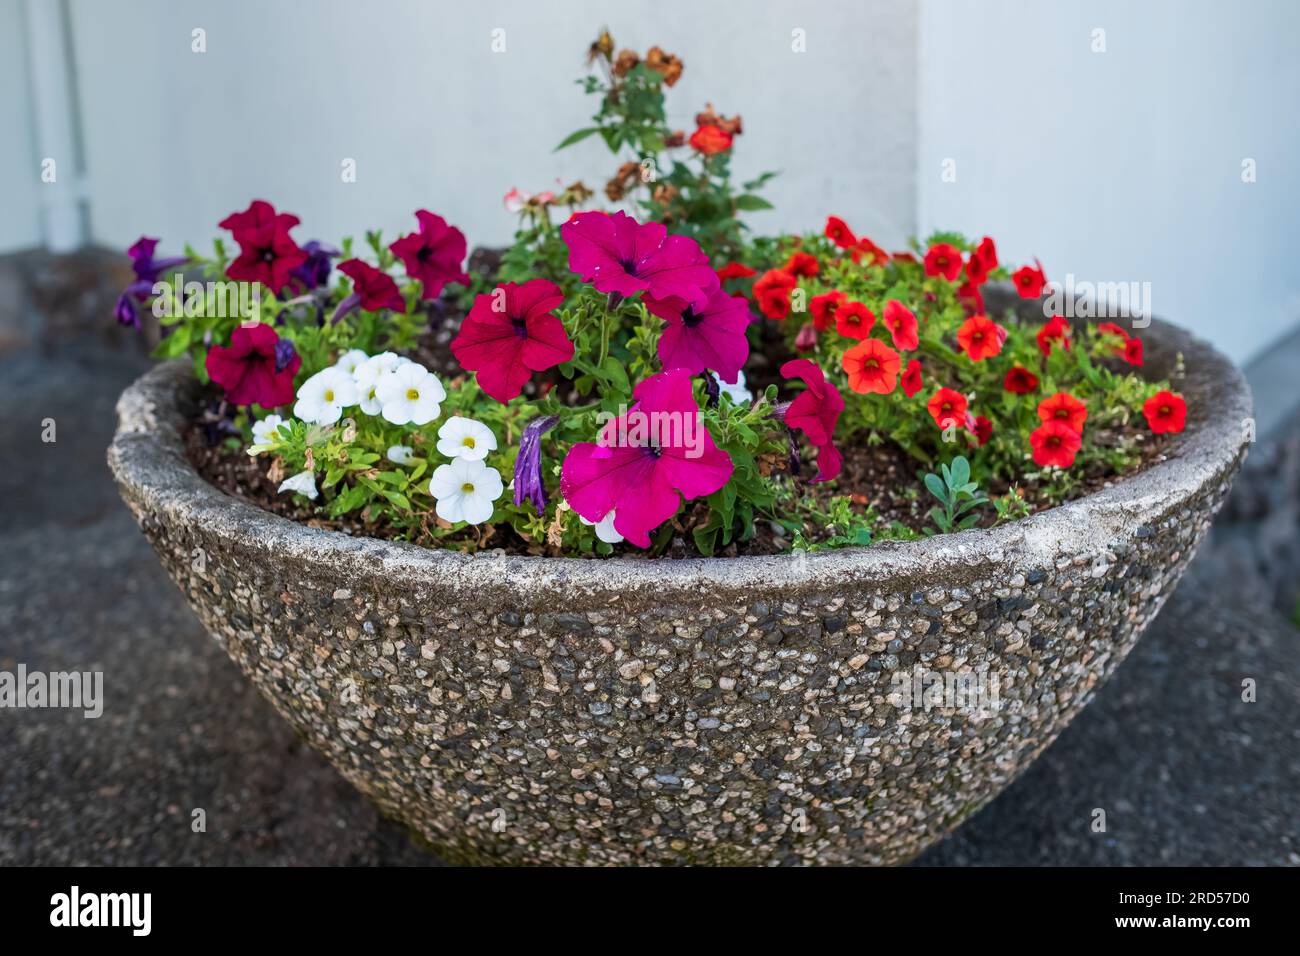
[560,368,732,548]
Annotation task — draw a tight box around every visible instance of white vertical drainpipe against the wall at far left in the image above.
[26,0,86,252]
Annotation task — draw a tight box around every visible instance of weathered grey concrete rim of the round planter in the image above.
[108,320,1252,606]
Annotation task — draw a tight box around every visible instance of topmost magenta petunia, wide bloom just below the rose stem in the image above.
[560,212,722,310]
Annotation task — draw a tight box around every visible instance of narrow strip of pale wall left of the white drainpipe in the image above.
[0,0,41,252]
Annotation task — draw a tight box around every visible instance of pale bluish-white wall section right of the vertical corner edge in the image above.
[918,0,1300,360]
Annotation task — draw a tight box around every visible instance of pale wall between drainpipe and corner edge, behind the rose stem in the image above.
[72,0,917,248]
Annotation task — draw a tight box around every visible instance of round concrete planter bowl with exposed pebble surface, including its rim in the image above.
[108,316,1251,864]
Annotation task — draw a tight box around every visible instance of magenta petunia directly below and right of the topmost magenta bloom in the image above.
[645,286,749,385]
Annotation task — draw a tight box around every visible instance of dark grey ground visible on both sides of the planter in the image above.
[0,260,1300,866]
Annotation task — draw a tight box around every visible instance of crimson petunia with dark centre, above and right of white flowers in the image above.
[451,278,573,405]
